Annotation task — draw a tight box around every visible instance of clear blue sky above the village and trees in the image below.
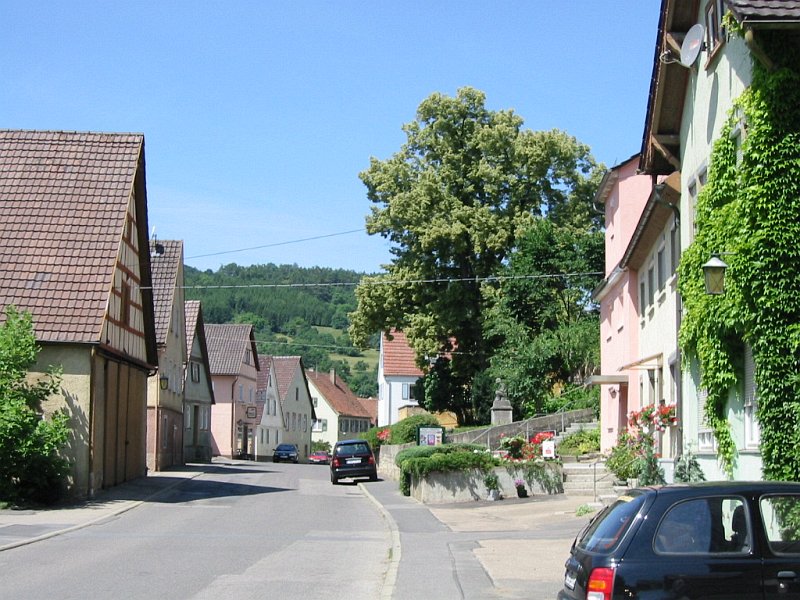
[0,0,660,272]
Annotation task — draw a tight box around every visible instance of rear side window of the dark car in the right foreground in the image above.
[653,496,752,554]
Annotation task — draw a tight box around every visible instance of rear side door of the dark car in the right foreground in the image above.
[615,496,763,600]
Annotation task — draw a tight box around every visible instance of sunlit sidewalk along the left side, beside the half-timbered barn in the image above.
[0,465,203,552]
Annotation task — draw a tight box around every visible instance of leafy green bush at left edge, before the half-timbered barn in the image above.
[0,306,69,503]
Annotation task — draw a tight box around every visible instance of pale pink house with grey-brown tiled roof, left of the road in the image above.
[205,324,263,458]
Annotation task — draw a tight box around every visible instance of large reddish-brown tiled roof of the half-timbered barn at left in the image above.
[0,130,148,350]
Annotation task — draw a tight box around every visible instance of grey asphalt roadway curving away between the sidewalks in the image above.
[0,463,392,600]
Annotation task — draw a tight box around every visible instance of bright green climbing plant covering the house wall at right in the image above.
[679,33,800,481]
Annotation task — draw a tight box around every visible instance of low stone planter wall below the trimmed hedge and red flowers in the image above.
[412,462,564,504]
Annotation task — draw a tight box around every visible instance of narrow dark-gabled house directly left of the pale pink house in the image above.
[183,300,214,462]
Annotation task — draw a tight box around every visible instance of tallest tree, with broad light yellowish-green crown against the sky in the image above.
[350,88,597,419]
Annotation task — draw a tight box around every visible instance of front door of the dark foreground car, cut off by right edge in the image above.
[758,494,800,600]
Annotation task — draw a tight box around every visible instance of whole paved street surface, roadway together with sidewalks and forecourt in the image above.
[0,461,589,600]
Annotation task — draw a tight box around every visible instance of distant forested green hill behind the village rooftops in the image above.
[184,264,377,396]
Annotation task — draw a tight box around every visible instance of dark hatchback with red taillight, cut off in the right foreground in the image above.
[558,481,800,600]
